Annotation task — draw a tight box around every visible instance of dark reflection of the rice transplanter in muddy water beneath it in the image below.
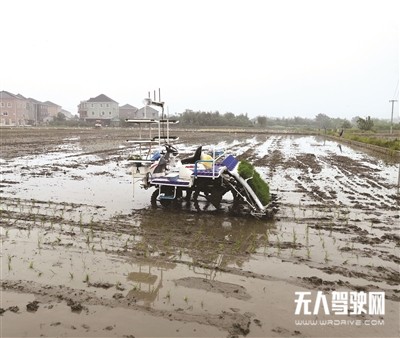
[134,209,276,270]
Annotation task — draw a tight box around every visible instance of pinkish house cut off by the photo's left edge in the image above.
[0,90,33,126]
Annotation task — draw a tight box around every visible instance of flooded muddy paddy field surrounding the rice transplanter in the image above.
[0,128,400,337]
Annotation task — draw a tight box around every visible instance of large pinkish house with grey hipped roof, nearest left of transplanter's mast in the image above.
[78,94,119,125]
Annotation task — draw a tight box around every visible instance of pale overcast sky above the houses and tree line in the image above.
[0,0,400,118]
